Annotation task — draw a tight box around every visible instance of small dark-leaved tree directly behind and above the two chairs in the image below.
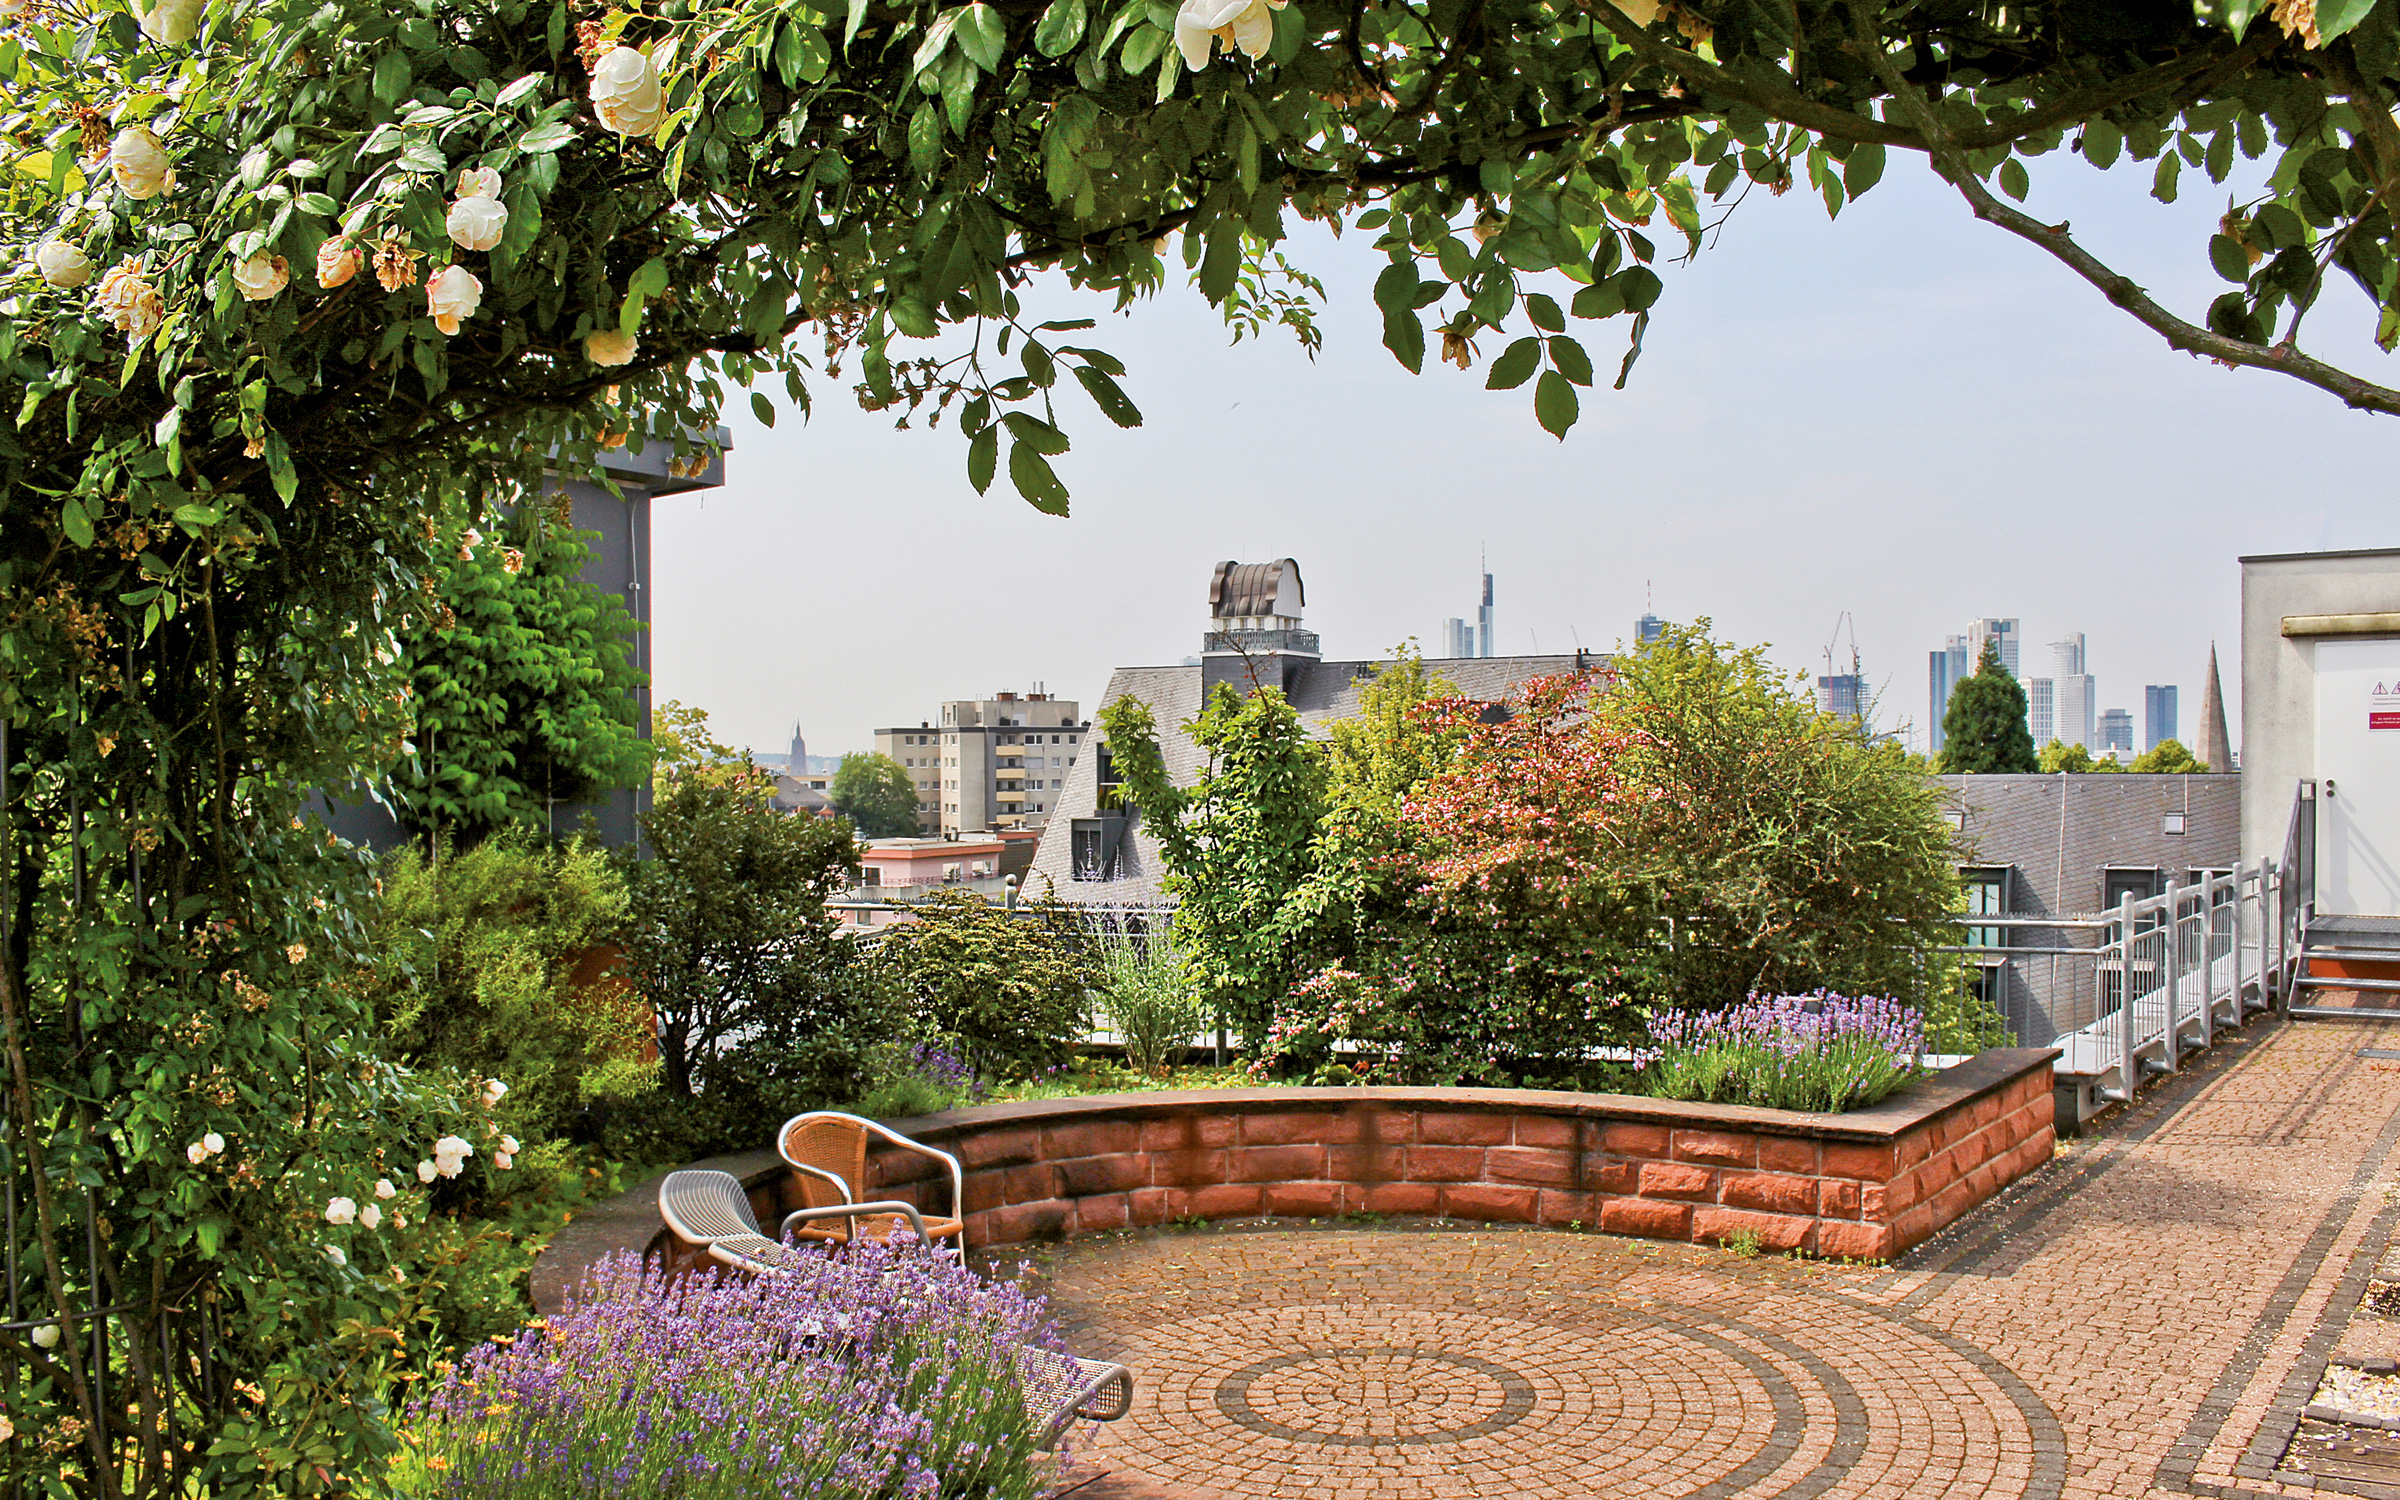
[624,753,859,1097]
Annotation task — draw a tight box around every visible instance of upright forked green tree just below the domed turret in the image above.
[1099,684,1327,1044]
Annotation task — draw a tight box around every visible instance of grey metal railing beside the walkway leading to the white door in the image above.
[1946,859,2299,1102]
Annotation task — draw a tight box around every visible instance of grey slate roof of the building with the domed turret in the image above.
[1025,653,1608,905]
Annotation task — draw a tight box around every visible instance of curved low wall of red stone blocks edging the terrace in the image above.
[533,1049,2057,1310]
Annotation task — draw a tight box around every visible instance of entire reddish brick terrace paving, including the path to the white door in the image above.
[1003,1022,2400,1500]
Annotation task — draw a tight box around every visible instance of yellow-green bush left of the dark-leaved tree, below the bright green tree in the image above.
[367,833,650,1138]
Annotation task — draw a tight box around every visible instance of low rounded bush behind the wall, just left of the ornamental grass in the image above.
[876,890,1094,1075]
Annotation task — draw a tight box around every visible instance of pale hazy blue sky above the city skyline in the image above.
[653,154,2400,754]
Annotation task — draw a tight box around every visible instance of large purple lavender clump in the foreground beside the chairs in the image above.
[396,1243,1058,1500]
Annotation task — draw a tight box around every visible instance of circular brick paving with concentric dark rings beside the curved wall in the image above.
[1022,1231,2054,1500]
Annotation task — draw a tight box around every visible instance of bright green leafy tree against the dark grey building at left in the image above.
[389,506,650,845]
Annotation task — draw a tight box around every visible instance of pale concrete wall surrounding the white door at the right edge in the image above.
[2239,547,2400,862]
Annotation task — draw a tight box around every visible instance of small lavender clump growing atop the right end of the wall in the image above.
[1634,989,1925,1111]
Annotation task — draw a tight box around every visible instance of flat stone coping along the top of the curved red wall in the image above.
[873,1046,2059,1154]
